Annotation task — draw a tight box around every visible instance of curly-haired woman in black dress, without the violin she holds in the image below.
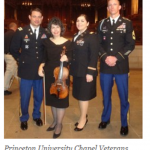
[39,17,71,138]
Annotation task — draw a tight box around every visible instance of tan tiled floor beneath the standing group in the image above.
[4,70,143,139]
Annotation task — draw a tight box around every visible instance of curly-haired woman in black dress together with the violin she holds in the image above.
[39,17,72,138]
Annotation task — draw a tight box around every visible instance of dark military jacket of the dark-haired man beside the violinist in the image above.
[10,25,47,80]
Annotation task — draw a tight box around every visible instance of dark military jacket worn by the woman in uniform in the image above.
[70,30,98,77]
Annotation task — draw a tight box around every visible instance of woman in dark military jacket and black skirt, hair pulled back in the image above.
[70,14,98,131]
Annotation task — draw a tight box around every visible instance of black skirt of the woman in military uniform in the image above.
[72,76,96,101]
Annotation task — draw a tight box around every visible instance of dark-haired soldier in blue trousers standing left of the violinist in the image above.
[10,8,47,130]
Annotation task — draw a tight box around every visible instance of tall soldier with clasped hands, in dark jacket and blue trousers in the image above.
[98,0,135,135]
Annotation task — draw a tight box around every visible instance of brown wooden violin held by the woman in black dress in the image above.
[50,46,69,99]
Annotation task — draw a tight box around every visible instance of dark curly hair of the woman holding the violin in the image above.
[47,17,65,36]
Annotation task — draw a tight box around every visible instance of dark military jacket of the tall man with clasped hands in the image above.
[97,16,135,74]
